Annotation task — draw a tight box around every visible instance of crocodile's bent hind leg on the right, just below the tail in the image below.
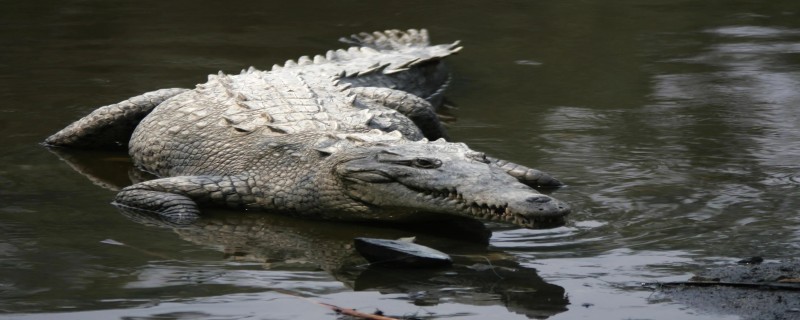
[350,87,447,140]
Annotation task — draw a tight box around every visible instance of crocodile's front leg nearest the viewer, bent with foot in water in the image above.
[113,176,255,224]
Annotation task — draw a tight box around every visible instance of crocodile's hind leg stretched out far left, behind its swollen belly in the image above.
[44,88,188,149]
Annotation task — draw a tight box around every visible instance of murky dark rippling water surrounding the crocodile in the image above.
[0,0,800,319]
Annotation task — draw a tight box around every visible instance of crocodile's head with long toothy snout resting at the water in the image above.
[324,140,570,228]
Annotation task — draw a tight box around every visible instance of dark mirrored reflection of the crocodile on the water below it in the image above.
[48,152,569,318]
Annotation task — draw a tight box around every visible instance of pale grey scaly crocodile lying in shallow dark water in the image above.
[44,29,570,228]
